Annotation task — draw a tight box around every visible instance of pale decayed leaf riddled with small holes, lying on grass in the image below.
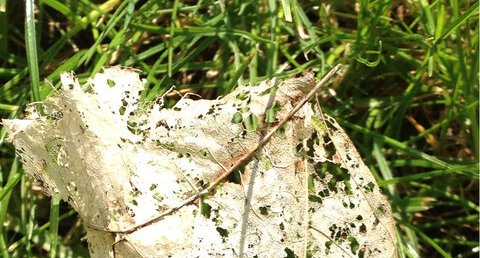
[3,67,396,257]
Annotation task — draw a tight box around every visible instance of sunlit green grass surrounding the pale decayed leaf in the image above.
[0,0,480,257]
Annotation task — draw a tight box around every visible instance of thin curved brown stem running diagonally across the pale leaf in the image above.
[87,64,342,234]
